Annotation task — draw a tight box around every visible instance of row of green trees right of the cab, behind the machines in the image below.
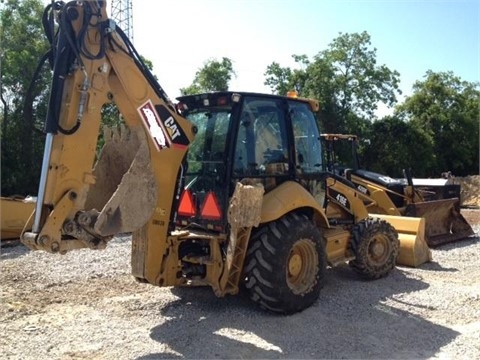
[265,32,480,177]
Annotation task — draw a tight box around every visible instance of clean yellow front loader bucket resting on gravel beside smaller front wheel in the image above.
[372,214,432,267]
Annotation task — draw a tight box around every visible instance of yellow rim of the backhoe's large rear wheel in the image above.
[286,239,318,294]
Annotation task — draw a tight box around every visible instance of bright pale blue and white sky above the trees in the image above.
[42,0,480,109]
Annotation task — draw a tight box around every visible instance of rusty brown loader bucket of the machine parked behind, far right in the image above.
[405,198,474,247]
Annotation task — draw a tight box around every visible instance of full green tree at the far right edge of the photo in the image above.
[396,70,480,176]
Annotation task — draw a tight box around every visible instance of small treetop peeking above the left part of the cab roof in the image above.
[180,57,235,95]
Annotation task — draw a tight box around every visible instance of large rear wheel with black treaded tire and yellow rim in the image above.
[244,213,327,314]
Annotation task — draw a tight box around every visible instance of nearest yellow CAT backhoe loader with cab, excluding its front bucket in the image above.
[21,1,428,313]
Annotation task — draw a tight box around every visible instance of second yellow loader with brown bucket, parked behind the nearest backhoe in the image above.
[322,134,474,247]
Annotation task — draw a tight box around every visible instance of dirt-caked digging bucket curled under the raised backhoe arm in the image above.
[85,127,157,236]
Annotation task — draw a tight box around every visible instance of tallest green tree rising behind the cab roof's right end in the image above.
[265,32,400,134]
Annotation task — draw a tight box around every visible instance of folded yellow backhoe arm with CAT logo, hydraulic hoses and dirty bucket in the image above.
[22,1,196,274]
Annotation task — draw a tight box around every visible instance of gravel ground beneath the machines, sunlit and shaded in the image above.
[0,210,480,359]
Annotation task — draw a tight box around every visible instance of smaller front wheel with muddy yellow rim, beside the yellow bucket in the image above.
[350,218,400,280]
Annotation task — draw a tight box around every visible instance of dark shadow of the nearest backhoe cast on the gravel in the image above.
[139,266,459,359]
